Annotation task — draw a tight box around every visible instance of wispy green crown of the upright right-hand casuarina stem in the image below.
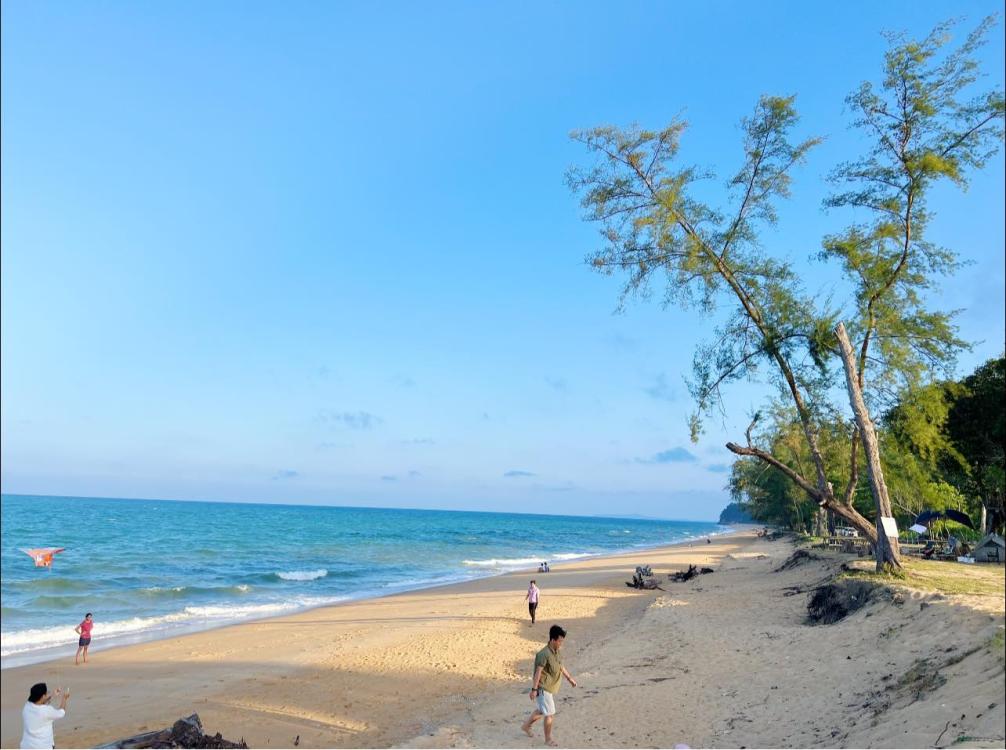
[821,17,1004,408]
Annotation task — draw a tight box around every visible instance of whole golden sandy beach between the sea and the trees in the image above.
[0,532,1006,747]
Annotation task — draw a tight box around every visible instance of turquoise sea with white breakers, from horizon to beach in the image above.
[0,495,727,669]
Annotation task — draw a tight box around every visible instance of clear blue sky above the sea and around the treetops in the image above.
[0,1,1006,519]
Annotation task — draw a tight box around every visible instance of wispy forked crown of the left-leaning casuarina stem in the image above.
[567,97,818,436]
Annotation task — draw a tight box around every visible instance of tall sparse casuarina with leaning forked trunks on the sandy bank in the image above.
[568,17,1002,562]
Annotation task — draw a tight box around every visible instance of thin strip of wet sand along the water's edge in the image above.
[0,522,740,672]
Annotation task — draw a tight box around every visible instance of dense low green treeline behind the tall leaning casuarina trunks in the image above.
[729,357,1006,536]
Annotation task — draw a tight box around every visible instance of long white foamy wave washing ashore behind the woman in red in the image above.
[0,596,348,657]
